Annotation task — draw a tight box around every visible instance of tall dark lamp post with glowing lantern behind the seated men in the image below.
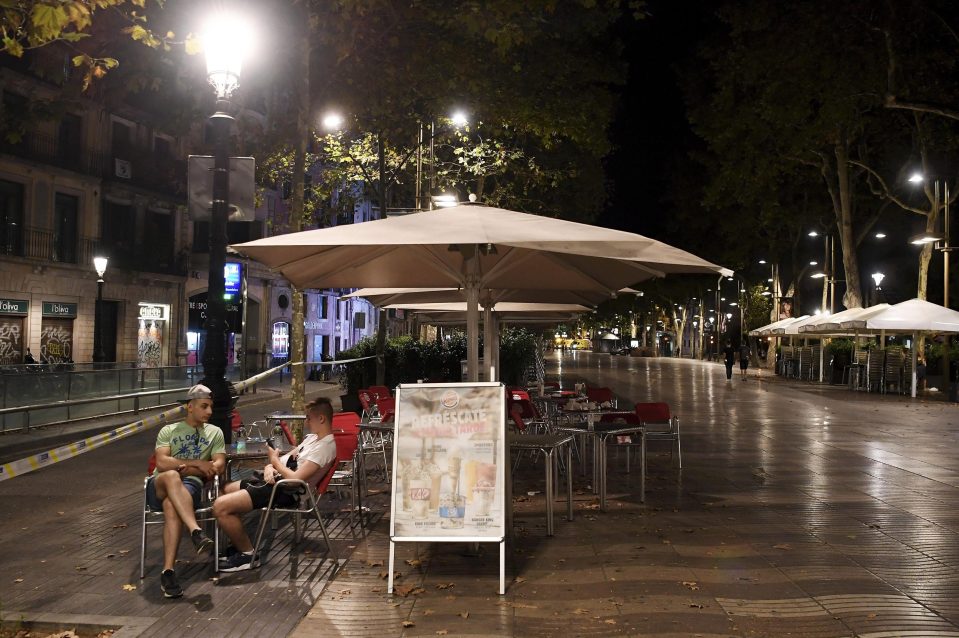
[202,15,248,443]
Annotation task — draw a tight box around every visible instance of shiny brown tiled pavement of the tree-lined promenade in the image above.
[0,353,959,638]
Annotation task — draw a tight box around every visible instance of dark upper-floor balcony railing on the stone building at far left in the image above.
[0,133,186,199]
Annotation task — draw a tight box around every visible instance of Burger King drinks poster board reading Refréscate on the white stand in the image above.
[390,383,509,541]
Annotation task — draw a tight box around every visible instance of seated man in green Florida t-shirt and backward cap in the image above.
[147,385,226,598]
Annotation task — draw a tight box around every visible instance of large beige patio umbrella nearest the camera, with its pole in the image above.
[233,205,731,380]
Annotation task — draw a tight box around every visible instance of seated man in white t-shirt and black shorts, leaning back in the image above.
[213,397,336,572]
